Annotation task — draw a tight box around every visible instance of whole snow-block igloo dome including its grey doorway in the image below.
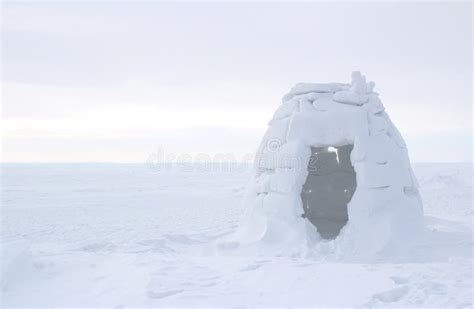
[235,72,423,255]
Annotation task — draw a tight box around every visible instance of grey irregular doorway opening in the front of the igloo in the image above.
[301,145,357,239]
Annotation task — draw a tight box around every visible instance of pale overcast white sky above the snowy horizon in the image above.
[1,2,473,162]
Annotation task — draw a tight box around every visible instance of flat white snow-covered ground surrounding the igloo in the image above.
[1,164,473,308]
